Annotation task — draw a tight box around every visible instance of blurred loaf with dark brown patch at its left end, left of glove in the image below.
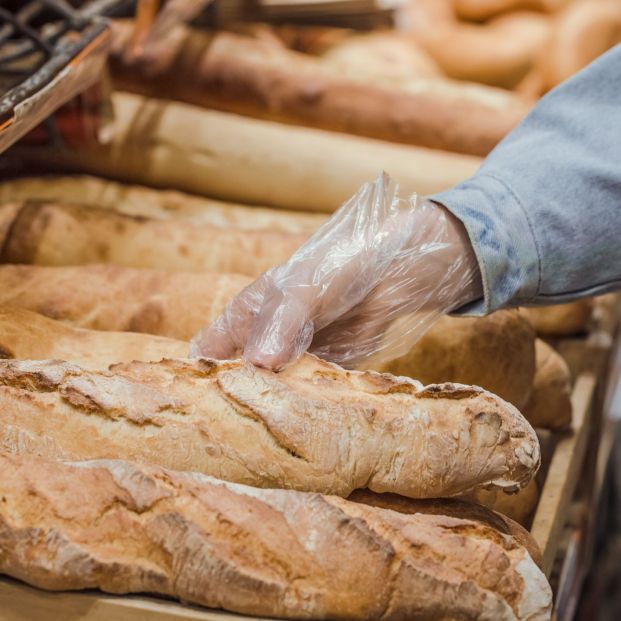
[0,201,309,276]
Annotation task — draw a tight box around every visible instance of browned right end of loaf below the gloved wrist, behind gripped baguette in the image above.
[371,311,535,409]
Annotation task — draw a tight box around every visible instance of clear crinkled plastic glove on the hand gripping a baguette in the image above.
[190,173,482,370]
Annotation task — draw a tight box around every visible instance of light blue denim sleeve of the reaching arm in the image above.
[430,45,621,315]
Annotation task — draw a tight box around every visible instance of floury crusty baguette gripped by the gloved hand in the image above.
[0,355,540,498]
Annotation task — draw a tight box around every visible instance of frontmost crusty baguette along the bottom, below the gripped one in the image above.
[0,456,552,621]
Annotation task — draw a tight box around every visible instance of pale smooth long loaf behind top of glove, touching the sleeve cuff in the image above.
[12,93,481,213]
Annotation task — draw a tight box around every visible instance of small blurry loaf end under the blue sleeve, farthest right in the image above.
[520,299,595,336]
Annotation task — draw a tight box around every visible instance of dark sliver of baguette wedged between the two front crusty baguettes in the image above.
[347,486,542,566]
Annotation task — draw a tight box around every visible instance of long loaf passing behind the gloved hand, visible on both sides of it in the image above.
[0,265,535,408]
